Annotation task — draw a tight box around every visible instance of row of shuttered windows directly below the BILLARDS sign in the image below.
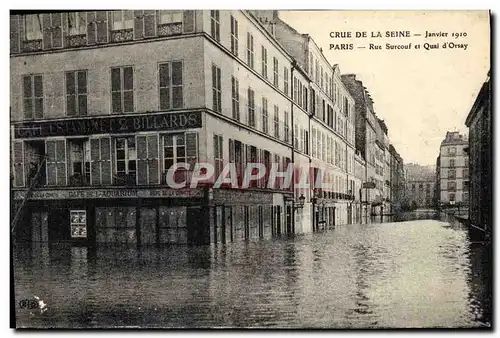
[14,132,198,186]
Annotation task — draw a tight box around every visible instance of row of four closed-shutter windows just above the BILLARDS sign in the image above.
[23,61,184,119]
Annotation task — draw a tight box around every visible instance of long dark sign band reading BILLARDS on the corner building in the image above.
[14,111,202,138]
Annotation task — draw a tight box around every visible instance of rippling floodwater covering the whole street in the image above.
[13,215,491,328]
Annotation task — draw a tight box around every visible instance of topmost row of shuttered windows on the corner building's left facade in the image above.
[15,10,194,52]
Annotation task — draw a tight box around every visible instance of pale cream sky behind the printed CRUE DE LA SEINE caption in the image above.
[279,11,490,165]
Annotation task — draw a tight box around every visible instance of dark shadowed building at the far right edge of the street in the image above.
[465,73,493,230]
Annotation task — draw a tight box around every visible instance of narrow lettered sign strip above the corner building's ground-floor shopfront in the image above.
[14,188,203,200]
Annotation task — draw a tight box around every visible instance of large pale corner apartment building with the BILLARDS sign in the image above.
[10,10,302,244]
